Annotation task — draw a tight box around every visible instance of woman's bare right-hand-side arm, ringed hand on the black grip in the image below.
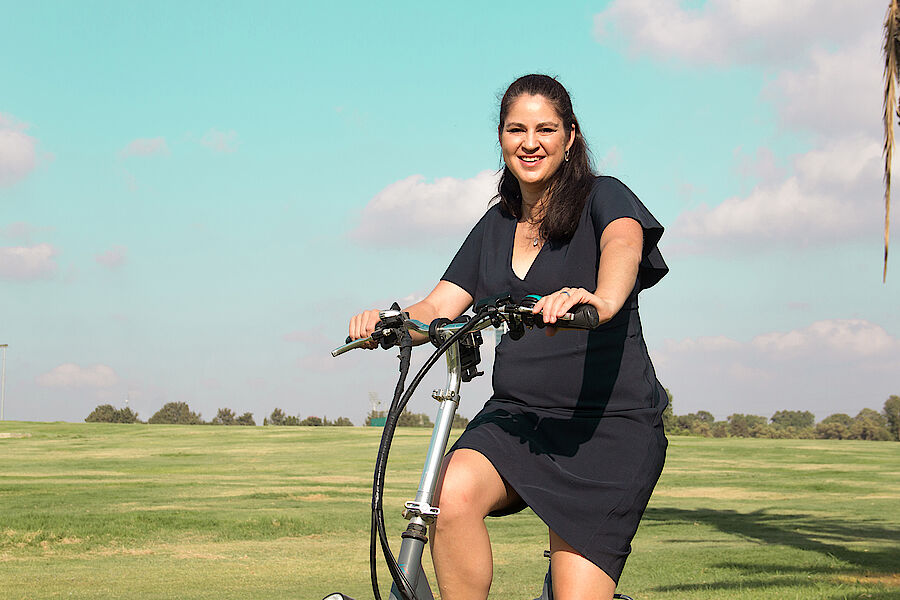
[534,217,644,326]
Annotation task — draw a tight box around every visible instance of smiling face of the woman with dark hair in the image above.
[500,95,575,194]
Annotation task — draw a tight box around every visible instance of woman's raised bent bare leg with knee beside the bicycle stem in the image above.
[431,448,518,600]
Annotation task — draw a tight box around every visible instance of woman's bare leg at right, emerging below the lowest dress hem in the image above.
[550,529,616,600]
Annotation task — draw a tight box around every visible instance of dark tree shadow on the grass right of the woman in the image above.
[644,508,900,599]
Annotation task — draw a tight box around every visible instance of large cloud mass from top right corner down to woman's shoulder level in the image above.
[595,0,896,252]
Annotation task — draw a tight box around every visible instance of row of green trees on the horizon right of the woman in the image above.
[663,390,900,441]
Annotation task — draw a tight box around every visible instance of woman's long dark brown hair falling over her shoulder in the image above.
[495,75,594,241]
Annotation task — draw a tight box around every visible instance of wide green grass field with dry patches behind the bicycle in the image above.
[0,422,900,600]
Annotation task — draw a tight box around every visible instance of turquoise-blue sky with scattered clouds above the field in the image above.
[0,0,900,423]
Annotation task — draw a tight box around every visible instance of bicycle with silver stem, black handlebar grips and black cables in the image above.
[323,295,633,600]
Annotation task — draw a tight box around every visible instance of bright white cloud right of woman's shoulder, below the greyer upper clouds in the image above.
[671,136,882,251]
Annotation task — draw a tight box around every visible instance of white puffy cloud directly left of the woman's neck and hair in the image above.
[350,171,499,246]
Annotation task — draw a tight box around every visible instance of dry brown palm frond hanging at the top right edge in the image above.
[882,0,900,282]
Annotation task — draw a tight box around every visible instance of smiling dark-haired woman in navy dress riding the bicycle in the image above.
[350,75,668,600]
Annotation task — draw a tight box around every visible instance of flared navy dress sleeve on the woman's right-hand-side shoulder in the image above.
[591,177,669,290]
